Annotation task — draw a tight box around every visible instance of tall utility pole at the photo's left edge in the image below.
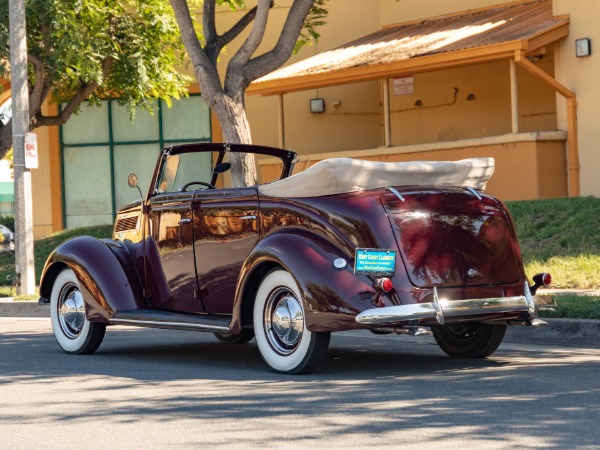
[8,0,35,295]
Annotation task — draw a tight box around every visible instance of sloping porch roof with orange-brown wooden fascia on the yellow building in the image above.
[247,0,569,95]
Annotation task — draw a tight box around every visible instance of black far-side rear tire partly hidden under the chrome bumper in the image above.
[431,322,506,358]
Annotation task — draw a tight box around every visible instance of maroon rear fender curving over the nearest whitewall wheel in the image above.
[232,230,373,331]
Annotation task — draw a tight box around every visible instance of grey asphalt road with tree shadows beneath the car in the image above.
[0,318,600,450]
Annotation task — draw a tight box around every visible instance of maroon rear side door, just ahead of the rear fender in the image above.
[193,186,259,314]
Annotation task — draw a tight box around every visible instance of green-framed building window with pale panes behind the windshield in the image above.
[60,95,211,228]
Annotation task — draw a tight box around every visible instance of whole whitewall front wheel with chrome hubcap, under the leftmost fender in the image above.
[50,269,106,355]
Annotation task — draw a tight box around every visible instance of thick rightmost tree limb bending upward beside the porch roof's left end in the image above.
[244,0,315,84]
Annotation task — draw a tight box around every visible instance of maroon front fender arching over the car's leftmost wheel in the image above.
[40,236,147,322]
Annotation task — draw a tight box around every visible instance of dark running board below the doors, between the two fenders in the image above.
[110,309,231,333]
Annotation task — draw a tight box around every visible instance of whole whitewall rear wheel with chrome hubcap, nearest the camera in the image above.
[253,269,330,374]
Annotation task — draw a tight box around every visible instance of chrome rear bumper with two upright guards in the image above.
[355,283,556,325]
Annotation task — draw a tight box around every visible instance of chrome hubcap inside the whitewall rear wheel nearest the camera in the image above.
[264,288,304,356]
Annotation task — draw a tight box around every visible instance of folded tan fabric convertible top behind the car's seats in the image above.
[258,158,494,197]
